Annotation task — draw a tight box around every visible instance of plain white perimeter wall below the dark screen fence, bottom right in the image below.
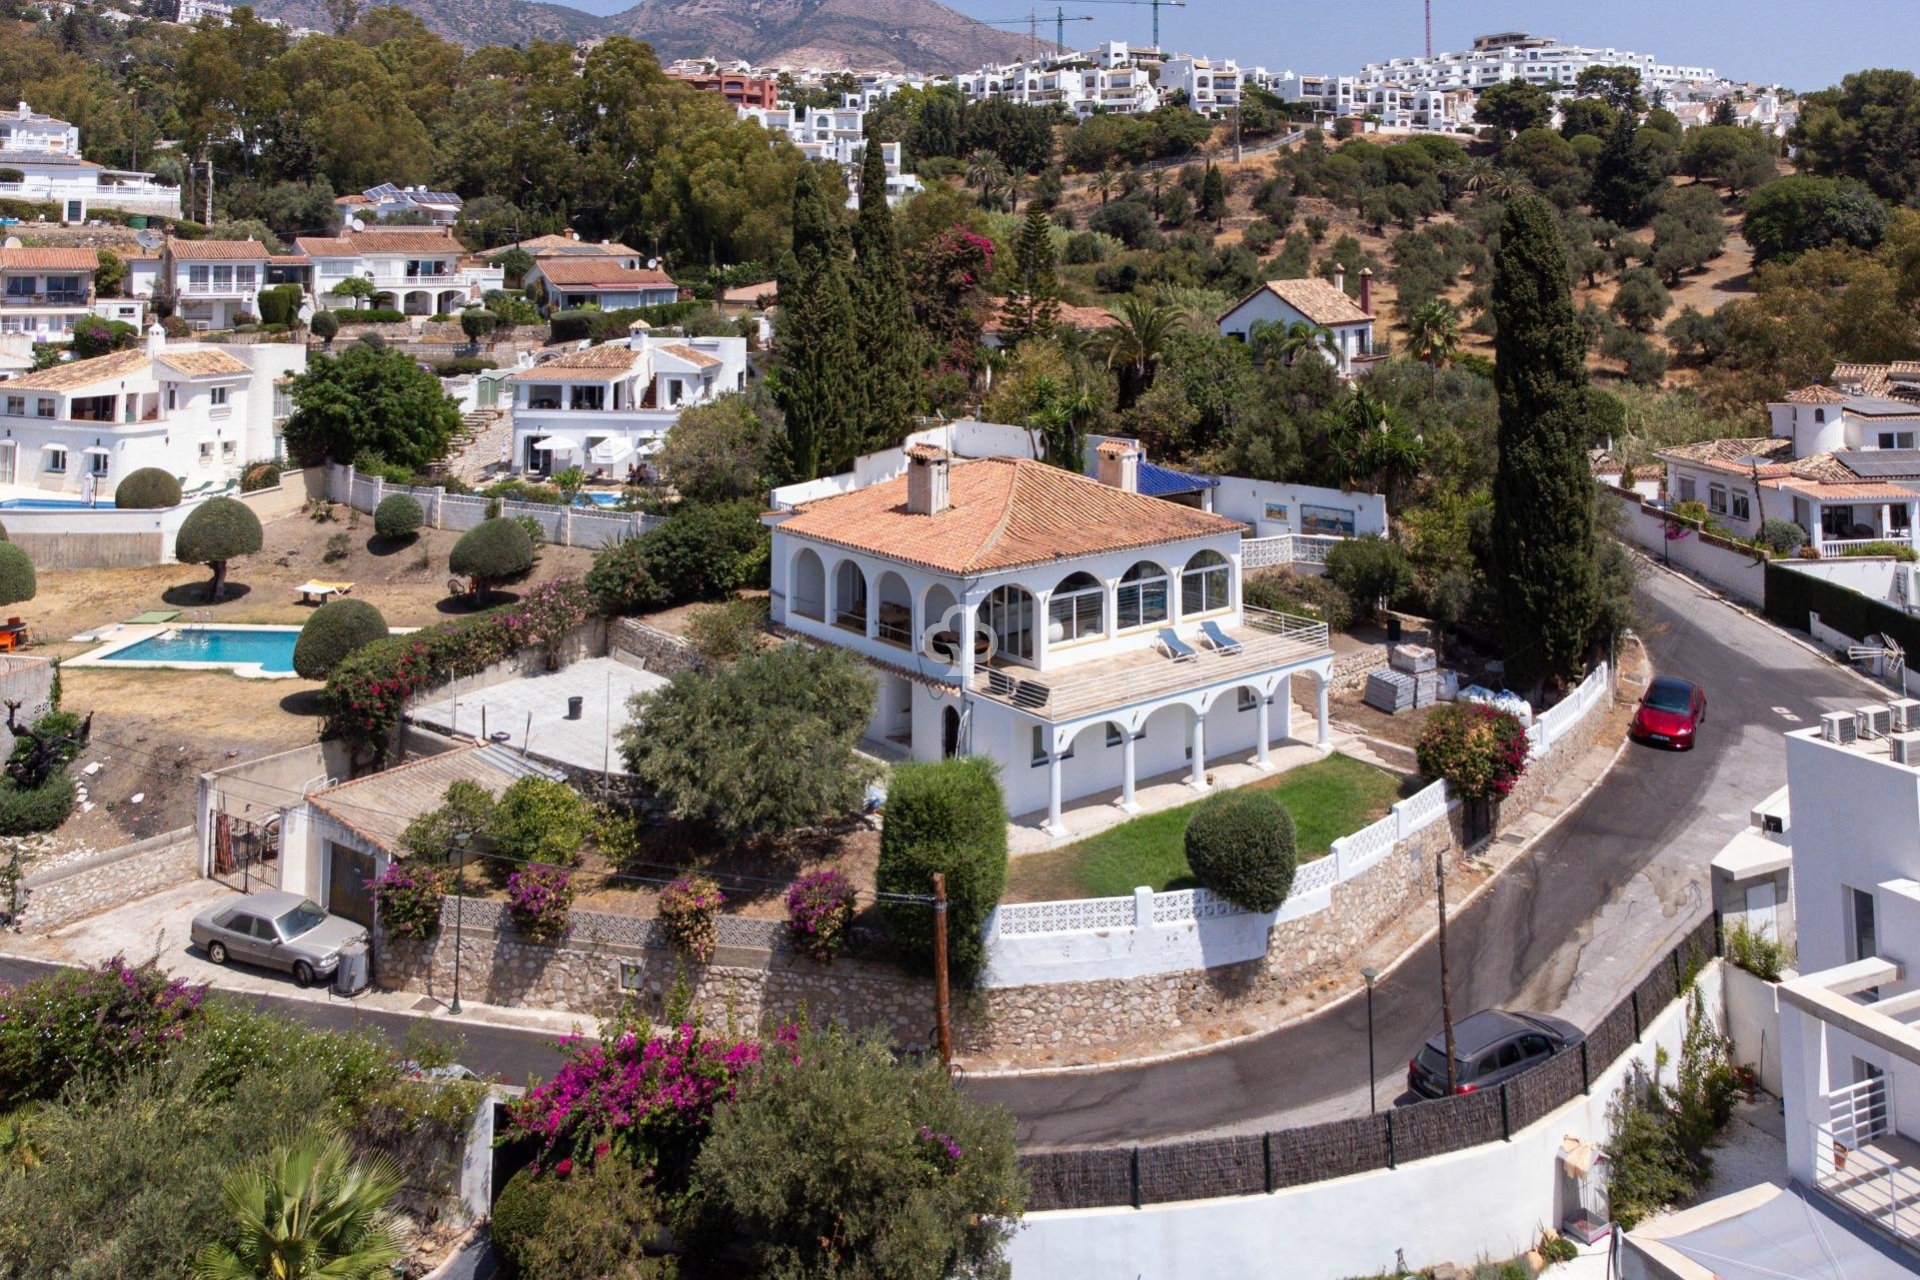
[1008,961,1722,1280]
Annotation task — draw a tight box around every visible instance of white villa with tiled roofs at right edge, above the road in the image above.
[1655,361,1920,555]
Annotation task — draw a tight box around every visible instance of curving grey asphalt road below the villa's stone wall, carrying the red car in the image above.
[968,572,1872,1148]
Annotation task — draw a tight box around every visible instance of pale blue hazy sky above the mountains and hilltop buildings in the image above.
[572,0,1920,90]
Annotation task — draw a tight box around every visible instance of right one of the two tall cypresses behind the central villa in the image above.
[852,138,922,451]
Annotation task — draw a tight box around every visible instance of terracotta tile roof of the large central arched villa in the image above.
[778,459,1244,574]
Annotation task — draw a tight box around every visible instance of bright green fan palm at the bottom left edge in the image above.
[194,1132,407,1280]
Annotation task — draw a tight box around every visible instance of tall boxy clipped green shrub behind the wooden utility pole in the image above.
[874,756,1006,979]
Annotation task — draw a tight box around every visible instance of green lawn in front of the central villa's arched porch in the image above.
[1006,756,1402,902]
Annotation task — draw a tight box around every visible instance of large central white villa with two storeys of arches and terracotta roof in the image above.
[766,441,1332,833]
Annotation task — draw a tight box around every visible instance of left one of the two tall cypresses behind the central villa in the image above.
[774,165,860,480]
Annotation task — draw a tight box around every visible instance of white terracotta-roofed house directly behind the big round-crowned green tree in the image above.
[296,226,507,315]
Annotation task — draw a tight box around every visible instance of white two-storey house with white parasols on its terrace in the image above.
[507,324,747,478]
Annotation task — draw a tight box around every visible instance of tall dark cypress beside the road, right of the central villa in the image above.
[1492,196,1597,681]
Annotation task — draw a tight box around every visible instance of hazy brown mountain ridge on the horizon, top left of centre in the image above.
[255,0,1029,75]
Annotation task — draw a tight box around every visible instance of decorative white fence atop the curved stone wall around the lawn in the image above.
[983,664,1613,986]
